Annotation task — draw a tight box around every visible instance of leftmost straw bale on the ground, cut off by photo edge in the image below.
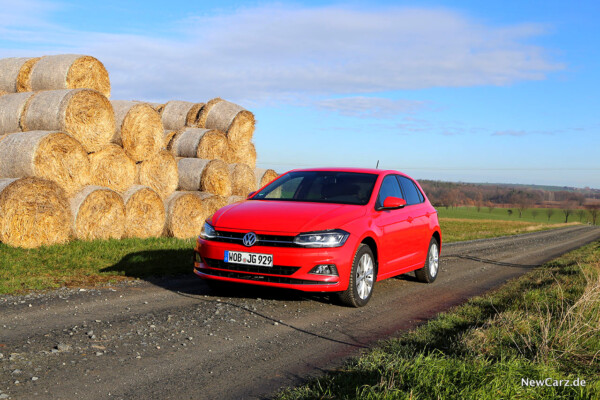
[0,177,71,248]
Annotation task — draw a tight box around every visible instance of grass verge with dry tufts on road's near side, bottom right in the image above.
[277,242,600,400]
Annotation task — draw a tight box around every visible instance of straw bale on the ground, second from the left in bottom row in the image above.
[71,186,125,240]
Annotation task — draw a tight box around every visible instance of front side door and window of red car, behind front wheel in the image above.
[374,175,415,279]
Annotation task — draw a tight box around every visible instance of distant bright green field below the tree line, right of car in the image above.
[437,207,591,224]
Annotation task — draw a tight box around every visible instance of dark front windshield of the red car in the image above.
[252,171,377,205]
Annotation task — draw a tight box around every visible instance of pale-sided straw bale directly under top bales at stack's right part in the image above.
[168,128,229,160]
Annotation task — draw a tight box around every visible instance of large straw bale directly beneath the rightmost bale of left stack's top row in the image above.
[22,89,115,152]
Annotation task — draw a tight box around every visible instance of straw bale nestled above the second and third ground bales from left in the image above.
[89,144,137,193]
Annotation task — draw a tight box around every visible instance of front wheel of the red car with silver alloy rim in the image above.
[339,244,376,307]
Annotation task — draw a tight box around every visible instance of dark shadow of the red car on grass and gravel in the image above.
[100,249,338,304]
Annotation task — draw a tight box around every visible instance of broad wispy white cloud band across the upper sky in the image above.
[0,3,564,104]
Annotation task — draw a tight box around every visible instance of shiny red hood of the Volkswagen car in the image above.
[212,200,366,234]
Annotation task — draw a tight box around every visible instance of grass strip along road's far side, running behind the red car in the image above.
[0,208,580,294]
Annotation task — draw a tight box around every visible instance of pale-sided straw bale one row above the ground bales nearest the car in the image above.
[177,158,231,197]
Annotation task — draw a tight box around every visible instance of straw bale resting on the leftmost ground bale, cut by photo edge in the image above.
[0,131,90,196]
